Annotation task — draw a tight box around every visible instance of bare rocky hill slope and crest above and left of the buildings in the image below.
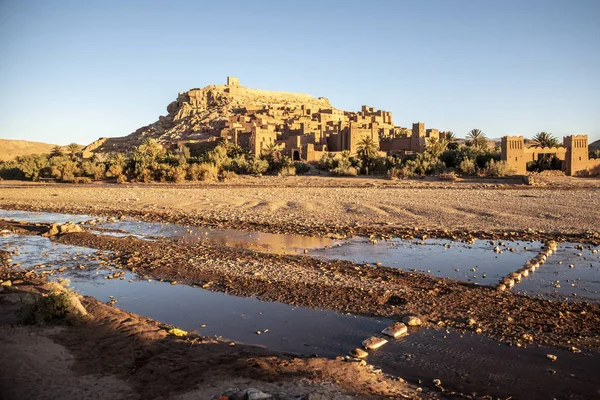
[84,80,333,155]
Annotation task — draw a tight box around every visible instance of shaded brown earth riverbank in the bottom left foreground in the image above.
[0,255,432,400]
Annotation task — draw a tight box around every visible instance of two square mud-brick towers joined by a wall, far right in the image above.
[501,135,600,176]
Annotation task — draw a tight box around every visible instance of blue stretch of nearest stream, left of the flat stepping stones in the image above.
[0,235,390,357]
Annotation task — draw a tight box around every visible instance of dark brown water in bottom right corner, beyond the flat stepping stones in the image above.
[369,329,600,399]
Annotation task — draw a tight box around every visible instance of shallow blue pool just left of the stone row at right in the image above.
[308,239,542,285]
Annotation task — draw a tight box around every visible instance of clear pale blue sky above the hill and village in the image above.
[0,0,600,144]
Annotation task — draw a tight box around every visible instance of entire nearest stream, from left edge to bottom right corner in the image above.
[0,230,600,399]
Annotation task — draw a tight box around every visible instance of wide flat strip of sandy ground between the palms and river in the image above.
[0,177,600,238]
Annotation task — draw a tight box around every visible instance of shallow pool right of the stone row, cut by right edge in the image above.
[513,243,600,303]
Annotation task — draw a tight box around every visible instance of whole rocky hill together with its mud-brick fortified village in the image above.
[84,77,440,161]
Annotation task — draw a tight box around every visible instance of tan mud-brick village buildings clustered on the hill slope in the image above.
[220,77,440,161]
